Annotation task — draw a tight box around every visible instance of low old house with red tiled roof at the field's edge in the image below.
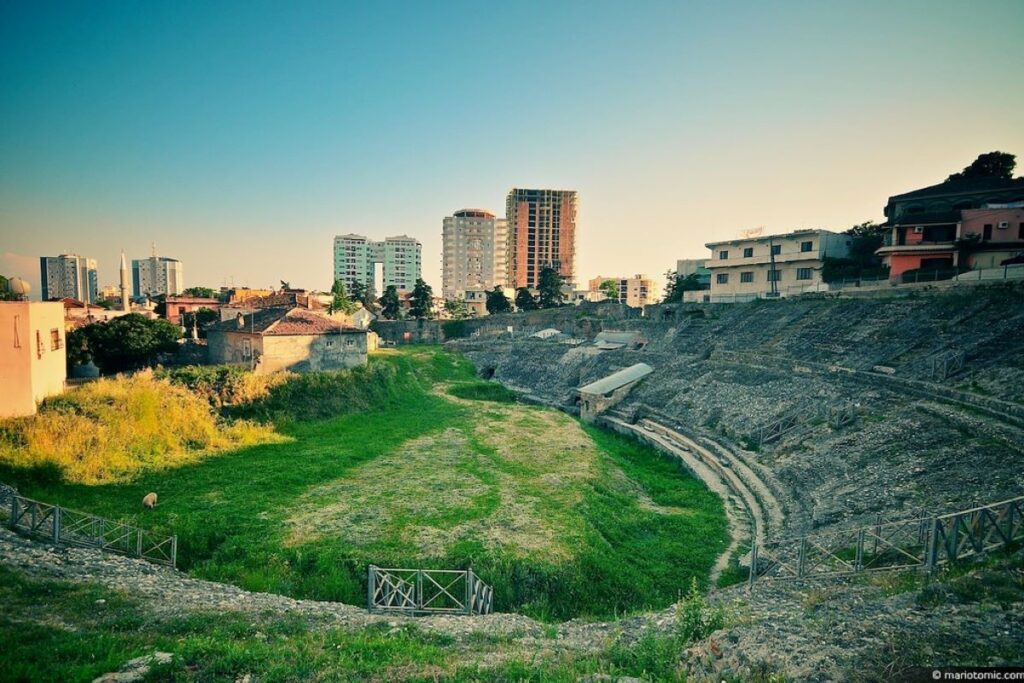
[207,306,368,374]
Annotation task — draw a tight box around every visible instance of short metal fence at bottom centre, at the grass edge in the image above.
[367,564,495,614]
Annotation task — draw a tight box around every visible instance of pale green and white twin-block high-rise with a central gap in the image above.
[334,233,423,296]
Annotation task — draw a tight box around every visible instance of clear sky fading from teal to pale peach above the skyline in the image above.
[0,0,1024,293]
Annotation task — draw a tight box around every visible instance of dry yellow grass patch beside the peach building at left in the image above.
[0,372,282,484]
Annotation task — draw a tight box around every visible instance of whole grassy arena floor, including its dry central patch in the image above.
[0,347,727,620]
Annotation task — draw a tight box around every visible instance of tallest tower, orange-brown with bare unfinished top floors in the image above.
[505,188,578,288]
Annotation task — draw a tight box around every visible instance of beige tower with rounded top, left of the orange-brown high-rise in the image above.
[441,209,508,299]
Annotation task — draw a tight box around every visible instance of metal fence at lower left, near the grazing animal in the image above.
[7,496,178,567]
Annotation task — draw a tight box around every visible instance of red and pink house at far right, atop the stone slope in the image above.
[877,202,1024,281]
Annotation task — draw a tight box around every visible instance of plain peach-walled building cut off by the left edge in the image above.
[0,301,68,418]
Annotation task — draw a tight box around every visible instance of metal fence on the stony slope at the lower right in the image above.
[750,496,1024,587]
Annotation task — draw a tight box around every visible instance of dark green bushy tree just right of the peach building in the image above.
[75,313,181,374]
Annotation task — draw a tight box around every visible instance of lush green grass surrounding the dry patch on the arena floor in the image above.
[0,348,726,618]
